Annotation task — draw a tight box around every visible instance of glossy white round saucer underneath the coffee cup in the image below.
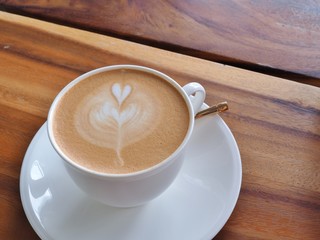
[20,115,242,240]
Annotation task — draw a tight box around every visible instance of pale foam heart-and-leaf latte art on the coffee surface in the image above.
[74,83,158,166]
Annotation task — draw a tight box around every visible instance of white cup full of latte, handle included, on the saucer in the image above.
[47,65,205,207]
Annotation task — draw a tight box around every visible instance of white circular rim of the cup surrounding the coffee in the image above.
[47,64,194,178]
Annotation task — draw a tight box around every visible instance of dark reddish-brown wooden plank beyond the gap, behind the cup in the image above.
[0,0,320,86]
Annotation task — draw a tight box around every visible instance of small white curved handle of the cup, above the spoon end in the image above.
[183,82,206,115]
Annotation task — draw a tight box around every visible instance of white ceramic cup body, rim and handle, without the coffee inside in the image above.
[47,65,205,207]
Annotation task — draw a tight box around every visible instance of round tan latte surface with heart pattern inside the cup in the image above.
[52,69,190,174]
